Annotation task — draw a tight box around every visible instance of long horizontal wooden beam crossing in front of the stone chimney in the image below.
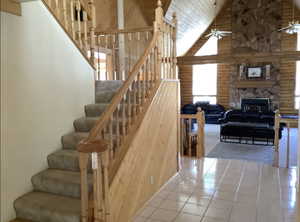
[177,51,300,65]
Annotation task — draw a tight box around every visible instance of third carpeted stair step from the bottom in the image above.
[48,149,91,172]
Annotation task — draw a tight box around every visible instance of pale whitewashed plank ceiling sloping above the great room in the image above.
[166,0,227,56]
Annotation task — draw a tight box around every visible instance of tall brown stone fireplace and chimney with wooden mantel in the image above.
[230,0,282,108]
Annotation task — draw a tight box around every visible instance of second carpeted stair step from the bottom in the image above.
[31,169,92,198]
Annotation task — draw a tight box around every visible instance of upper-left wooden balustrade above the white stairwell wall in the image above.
[42,0,96,68]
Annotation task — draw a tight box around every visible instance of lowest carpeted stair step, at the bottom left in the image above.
[14,192,80,222]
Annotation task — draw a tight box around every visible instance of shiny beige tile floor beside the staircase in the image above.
[133,158,297,222]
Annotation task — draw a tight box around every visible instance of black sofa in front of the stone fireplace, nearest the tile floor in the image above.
[219,110,283,145]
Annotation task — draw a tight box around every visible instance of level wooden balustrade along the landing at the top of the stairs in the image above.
[96,27,153,80]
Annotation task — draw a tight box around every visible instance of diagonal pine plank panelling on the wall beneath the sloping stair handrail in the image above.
[110,81,179,222]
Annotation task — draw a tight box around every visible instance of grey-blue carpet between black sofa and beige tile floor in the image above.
[206,142,274,164]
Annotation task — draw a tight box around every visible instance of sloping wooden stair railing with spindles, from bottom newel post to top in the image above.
[78,0,177,222]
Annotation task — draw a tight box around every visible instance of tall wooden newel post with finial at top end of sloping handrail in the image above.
[154,0,164,79]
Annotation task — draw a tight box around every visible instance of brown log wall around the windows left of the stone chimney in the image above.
[179,0,232,107]
